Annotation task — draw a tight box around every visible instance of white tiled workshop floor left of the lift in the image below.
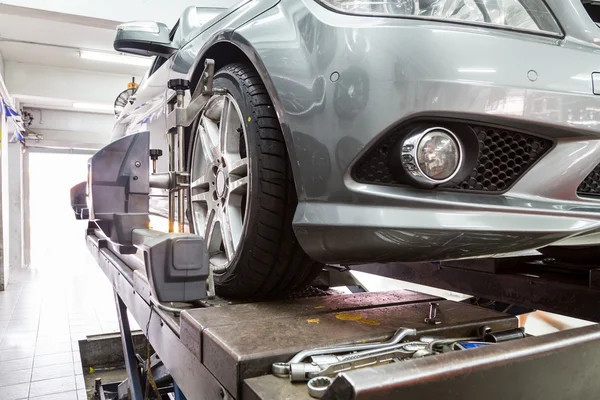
[0,238,123,400]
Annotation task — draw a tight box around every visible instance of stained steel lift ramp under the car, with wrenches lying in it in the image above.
[86,229,600,400]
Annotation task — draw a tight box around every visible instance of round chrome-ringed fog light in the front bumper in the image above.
[401,127,463,186]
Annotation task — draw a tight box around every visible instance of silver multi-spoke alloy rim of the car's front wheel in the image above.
[190,94,250,273]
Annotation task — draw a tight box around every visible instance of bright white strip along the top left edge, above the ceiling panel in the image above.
[0,0,239,27]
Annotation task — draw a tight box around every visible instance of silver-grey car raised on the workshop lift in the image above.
[109,0,600,297]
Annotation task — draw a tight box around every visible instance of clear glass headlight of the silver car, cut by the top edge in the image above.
[320,0,562,36]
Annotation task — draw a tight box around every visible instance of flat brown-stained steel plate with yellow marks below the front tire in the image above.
[181,291,517,396]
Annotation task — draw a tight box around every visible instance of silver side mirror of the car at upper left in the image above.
[114,21,177,57]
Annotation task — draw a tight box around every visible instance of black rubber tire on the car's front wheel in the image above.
[190,63,323,298]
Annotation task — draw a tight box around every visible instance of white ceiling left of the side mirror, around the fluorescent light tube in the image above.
[0,4,146,76]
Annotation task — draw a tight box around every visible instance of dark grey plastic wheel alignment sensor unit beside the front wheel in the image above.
[88,132,209,302]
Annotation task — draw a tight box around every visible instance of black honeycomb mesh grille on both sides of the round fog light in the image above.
[354,125,556,195]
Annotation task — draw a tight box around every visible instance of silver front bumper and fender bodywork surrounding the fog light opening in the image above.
[236,0,600,263]
